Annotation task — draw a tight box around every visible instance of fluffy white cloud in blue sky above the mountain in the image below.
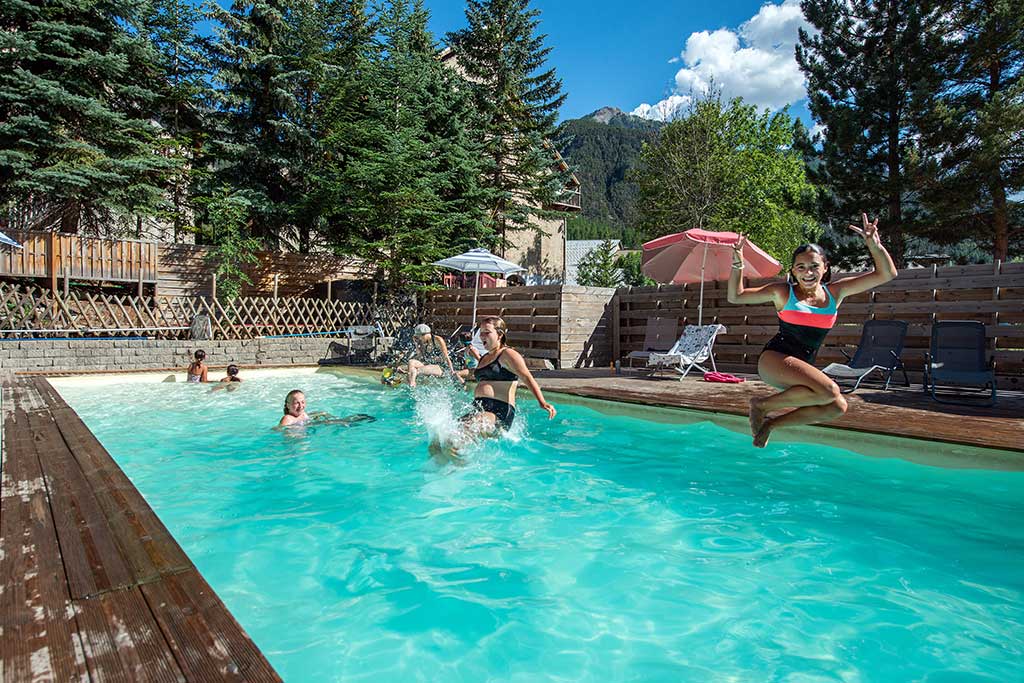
[633,0,811,121]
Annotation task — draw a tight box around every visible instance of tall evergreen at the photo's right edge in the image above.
[922,0,1024,260]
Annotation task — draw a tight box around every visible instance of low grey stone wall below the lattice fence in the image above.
[0,337,348,379]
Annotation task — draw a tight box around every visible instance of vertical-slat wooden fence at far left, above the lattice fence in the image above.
[0,231,159,290]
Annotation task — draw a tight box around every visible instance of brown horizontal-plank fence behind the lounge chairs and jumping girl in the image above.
[612,263,1024,388]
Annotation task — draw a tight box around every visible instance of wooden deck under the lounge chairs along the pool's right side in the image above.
[537,369,1024,454]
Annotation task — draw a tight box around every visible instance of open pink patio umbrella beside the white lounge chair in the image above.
[642,227,782,325]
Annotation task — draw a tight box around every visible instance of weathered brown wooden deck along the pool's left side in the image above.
[0,377,281,683]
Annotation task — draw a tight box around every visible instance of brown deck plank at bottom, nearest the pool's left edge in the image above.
[141,570,281,683]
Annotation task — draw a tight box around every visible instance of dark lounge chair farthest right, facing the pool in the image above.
[925,321,995,405]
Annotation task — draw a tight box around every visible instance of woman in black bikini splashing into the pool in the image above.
[430,316,557,461]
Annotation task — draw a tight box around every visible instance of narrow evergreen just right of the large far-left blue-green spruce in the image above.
[143,0,212,242]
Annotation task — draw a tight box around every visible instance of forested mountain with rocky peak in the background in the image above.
[556,106,665,237]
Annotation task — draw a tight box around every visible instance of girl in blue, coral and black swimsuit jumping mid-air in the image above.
[729,214,896,447]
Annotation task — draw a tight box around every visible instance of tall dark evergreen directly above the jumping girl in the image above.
[797,0,939,265]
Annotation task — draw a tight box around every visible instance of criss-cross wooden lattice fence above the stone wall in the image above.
[0,283,418,339]
